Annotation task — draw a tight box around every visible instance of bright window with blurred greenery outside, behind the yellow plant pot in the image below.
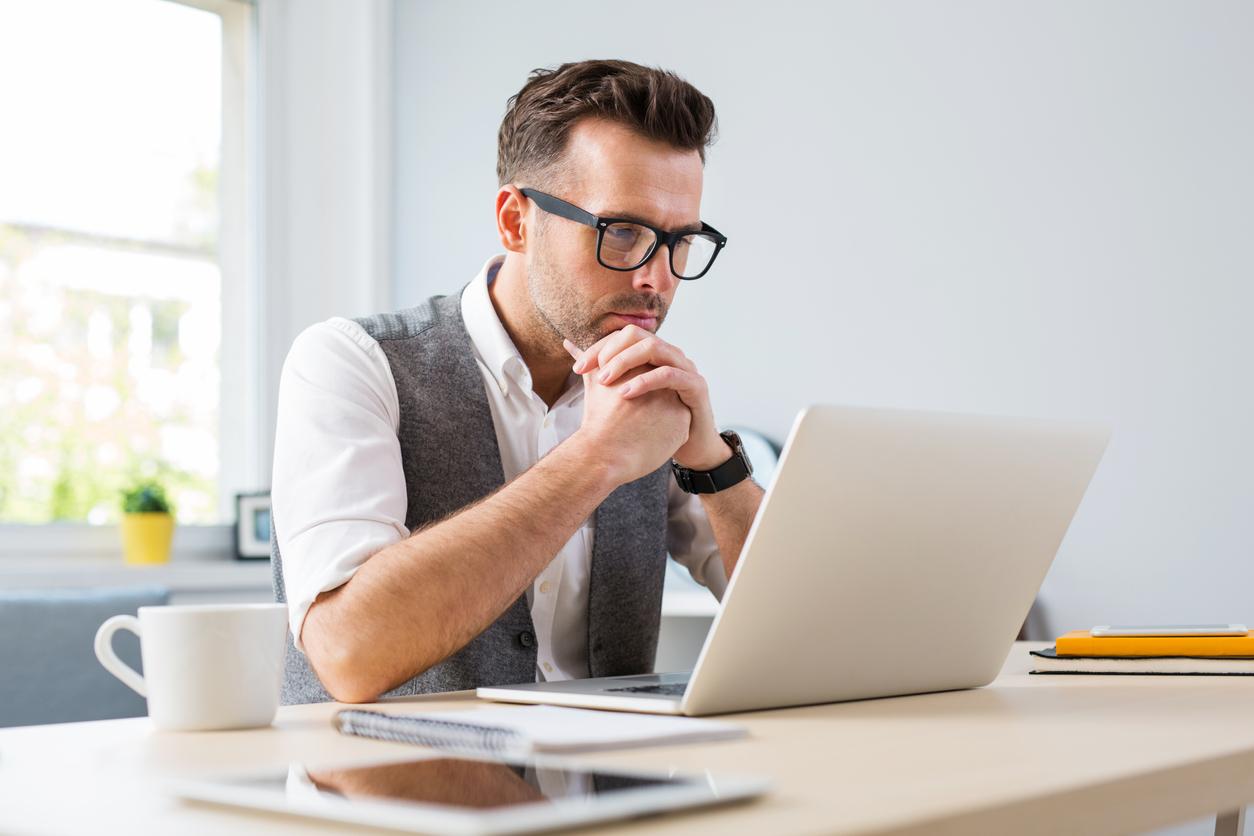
[0,0,258,524]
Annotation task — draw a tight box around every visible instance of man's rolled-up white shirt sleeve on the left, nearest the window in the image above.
[271,318,409,652]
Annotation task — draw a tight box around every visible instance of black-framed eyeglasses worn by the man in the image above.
[519,189,727,281]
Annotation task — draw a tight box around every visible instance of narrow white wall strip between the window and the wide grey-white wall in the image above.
[255,0,393,485]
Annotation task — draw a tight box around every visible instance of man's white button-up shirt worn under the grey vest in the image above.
[271,256,727,681]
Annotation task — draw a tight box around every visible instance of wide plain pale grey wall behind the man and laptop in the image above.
[394,0,1254,656]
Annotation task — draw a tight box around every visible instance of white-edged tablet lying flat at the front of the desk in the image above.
[168,753,767,833]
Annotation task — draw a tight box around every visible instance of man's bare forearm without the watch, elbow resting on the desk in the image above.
[301,436,617,702]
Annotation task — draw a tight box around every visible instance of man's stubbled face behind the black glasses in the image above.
[527,119,702,348]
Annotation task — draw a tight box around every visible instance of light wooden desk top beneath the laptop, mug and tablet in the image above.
[0,644,1254,836]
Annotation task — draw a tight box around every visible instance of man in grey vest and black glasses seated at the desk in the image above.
[273,61,762,702]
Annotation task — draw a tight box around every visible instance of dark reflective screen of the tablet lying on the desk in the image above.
[233,757,692,811]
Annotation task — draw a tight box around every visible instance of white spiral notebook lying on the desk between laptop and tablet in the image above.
[335,706,745,757]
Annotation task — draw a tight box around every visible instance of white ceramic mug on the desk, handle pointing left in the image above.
[95,604,287,731]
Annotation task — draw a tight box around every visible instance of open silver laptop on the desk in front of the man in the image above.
[478,406,1110,714]
